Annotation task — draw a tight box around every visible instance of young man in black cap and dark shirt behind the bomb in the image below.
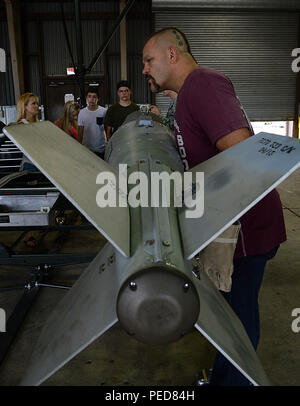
[104,80,139,140]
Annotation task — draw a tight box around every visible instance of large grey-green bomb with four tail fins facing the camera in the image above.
[4,112,300,385]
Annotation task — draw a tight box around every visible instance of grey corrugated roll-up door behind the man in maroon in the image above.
[155,9,299,121]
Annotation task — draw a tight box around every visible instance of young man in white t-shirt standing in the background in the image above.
[78,89,107,159]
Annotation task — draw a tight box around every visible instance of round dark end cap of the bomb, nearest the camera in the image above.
[117,267,200,345]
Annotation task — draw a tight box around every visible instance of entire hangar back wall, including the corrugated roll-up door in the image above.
[0,0,299,121]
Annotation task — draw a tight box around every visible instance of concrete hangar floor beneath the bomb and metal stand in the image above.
[0,170,300,386]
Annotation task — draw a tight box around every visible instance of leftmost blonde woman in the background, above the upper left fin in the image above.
[17,92,39,172]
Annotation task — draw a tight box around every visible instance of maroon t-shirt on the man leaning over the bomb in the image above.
[174,67,286,258]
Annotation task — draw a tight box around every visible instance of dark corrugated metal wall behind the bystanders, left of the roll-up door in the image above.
[0,0,151,105]
